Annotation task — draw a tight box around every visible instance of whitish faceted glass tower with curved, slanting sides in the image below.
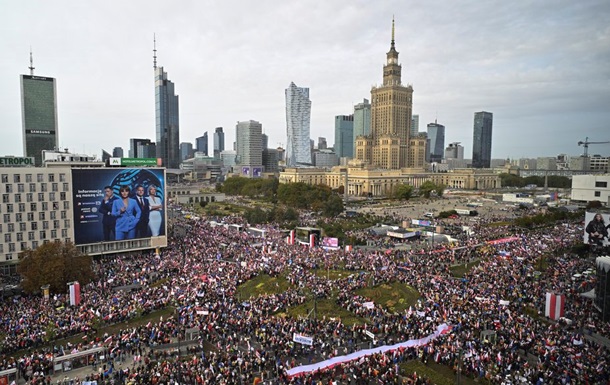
[286,83,312,167]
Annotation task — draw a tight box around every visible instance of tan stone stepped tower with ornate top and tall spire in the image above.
[356,20,416,169]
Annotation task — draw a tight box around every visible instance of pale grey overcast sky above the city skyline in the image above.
[0,0,610,158]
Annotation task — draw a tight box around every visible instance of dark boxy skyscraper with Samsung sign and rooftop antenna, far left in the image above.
[20,52,59,166]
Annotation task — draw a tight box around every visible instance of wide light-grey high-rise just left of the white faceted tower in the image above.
[235,120,263,167]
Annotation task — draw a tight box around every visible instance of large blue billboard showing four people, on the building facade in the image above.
[72,168,167,245]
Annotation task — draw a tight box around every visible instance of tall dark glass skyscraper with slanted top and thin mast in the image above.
[153,39,180,168]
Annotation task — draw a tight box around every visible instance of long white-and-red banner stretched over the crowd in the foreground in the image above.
[286,324,451,377]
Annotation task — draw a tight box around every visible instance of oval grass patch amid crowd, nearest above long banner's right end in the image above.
[356,282,419,313]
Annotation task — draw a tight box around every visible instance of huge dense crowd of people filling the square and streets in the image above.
[0,202,610,385]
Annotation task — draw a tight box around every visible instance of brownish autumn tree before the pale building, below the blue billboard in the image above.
[17,242,94,293]
